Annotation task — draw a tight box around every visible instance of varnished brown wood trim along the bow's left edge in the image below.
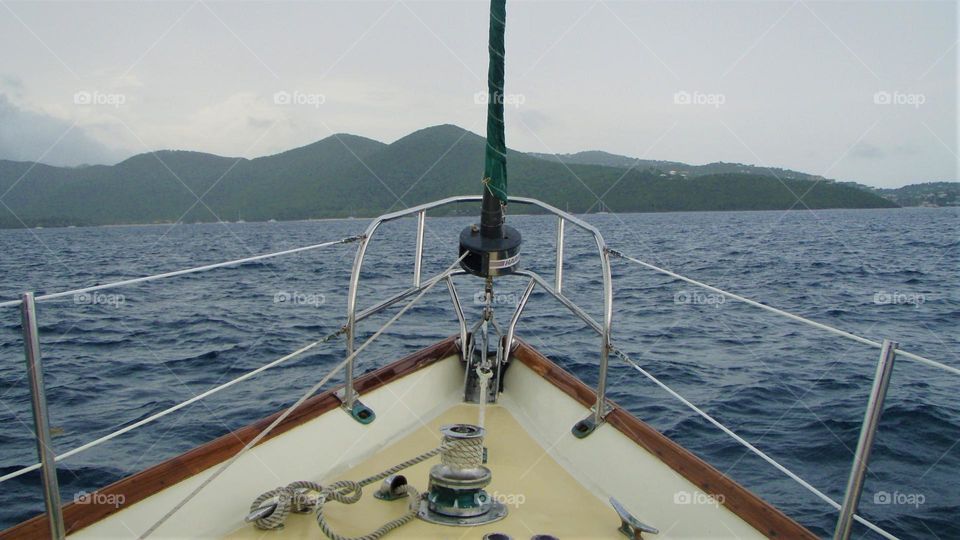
[0,337,458,540]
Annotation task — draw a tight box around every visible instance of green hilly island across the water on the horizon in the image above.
[0,125,948,228]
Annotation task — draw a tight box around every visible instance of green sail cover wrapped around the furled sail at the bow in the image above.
[483,0,507,204]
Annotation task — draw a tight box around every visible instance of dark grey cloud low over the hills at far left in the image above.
[0,94,127,166]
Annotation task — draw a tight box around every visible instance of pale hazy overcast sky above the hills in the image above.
[0,0,958,186]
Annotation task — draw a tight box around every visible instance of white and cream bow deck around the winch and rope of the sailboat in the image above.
[72,357,763,539]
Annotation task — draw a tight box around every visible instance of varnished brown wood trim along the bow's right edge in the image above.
[513,341,817,539]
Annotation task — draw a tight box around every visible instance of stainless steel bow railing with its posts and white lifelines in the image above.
[0,196,960,540]
